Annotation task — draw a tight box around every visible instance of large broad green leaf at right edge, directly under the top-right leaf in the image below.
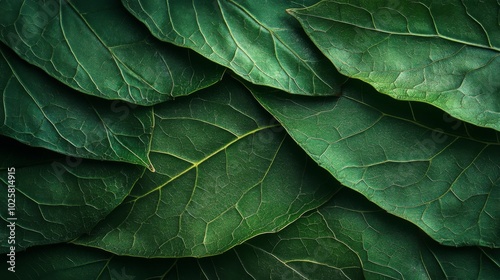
[252,80,500,247]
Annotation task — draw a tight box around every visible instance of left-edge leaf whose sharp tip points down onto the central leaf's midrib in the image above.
[0,43,153,169]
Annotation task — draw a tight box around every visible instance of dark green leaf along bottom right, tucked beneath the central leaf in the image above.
[245,189,500,279]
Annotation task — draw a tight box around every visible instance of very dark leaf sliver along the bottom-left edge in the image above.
[0,244,176,280]
